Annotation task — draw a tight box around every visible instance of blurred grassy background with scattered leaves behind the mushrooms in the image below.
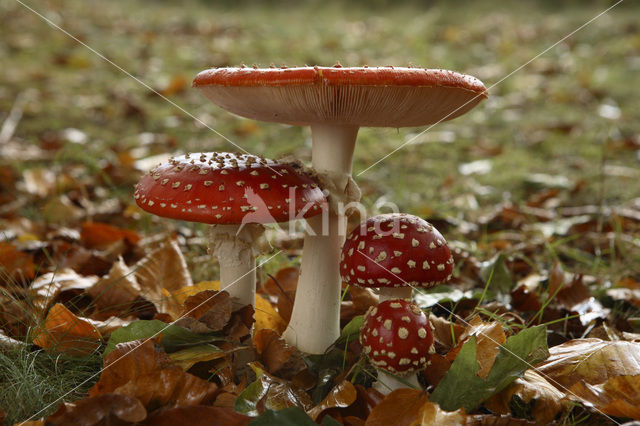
[0,0,640,272]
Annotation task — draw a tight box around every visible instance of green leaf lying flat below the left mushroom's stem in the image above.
[103,320,223,356]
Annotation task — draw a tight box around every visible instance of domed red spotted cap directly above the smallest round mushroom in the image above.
[340,213,453,288]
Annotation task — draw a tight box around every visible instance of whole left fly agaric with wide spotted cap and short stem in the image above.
[134,152,325,305]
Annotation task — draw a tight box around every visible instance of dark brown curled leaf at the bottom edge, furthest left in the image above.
[46,393,147,426]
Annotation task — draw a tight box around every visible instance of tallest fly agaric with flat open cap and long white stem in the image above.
[193,65,487,354]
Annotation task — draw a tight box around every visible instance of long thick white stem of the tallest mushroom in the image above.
[283,124,358,354]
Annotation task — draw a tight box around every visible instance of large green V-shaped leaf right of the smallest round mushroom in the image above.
[429,325,549,412]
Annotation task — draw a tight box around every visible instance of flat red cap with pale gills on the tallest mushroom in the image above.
[193,66,487,127]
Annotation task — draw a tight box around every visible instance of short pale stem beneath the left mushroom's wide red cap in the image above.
[209,223,266,306]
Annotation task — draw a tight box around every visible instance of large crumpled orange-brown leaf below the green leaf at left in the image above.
[89,340,218,410]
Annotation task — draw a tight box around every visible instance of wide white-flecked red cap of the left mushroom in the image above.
[134,152,325,224]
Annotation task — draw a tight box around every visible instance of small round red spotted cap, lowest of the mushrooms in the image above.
[360,299,433,374]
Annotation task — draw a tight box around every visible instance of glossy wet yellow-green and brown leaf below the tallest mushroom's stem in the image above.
[234,362,313,417]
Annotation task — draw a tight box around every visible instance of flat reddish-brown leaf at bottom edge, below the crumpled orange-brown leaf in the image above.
[142,406,252,426]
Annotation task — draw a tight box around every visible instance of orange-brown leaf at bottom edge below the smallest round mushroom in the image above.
[365,389,429,426]
